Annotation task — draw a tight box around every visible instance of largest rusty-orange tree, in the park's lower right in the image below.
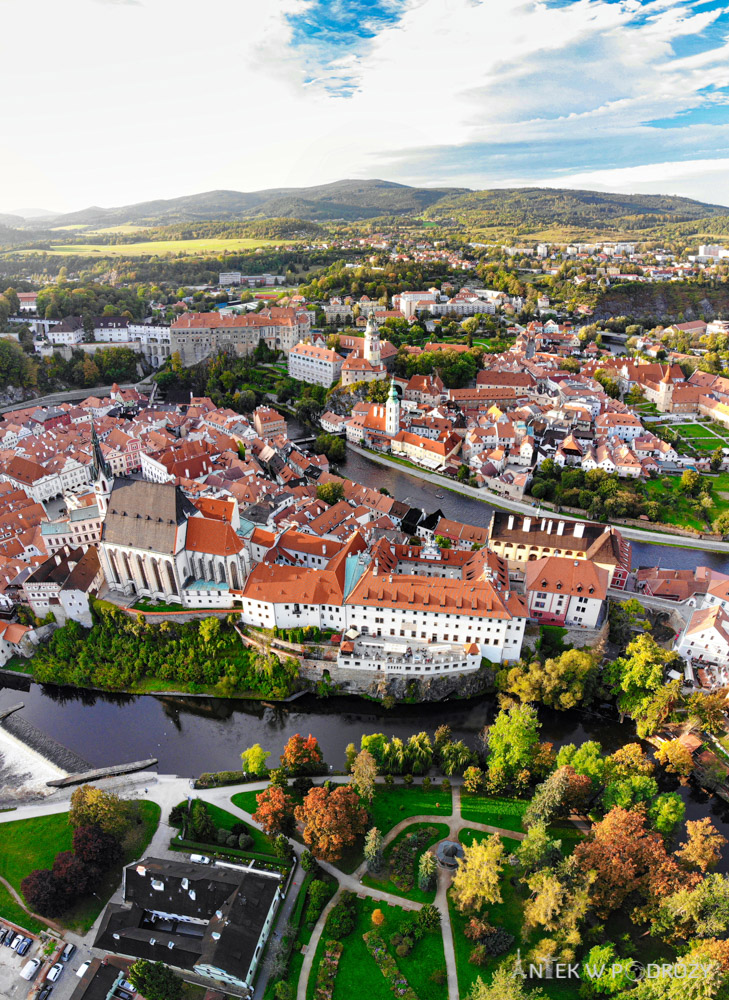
[573,807,686,917]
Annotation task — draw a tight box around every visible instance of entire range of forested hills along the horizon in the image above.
[8,180,729,242]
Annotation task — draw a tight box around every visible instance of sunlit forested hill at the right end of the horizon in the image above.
[424,188,729,235]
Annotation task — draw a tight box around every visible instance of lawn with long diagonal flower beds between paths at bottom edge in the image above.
[306,898,446,1000]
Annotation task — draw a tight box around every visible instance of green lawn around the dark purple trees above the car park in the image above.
[0,801,160,934]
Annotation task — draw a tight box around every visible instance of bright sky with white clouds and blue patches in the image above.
[0,0,729,212]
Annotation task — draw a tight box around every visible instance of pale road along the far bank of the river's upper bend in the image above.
[347,443,729,553]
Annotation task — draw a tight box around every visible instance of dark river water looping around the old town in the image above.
[0,438,729,860]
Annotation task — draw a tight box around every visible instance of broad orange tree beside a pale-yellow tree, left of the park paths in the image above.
[294,785,368,861]
